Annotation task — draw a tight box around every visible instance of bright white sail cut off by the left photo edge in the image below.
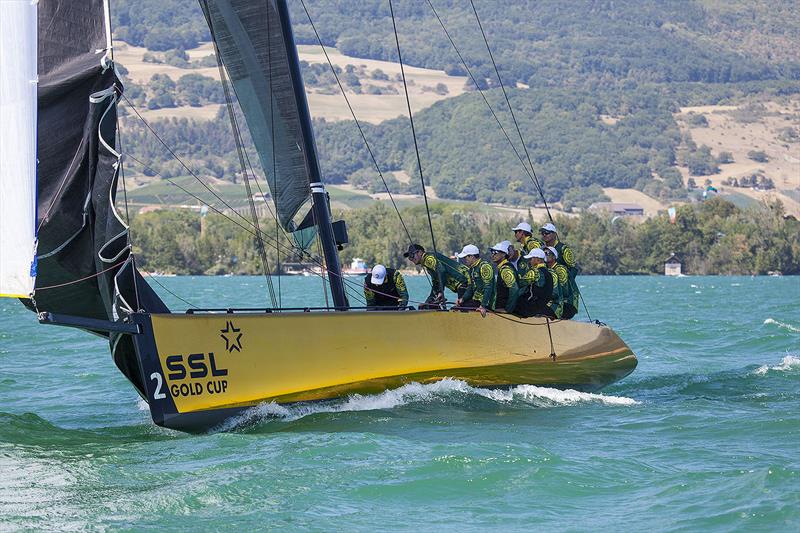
[0,0,37,297]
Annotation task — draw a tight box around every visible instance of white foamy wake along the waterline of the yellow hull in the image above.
[216,379,639,431]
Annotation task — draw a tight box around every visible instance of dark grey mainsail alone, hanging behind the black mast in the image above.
[200,0,316,231]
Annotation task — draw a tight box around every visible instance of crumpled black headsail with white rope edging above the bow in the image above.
[28,0,169,390]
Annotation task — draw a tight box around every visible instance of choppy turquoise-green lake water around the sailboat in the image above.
[0,277,800,532]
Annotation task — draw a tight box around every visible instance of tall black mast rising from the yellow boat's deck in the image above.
[276,0,349,308]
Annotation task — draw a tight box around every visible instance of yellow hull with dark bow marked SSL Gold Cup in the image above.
[134,311,636,429]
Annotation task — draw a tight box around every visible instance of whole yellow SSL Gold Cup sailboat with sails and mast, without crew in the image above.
[0,0,637,431]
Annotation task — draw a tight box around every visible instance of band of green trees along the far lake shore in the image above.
[131,198,800,274]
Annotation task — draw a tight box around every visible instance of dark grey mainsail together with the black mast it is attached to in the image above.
[200,0,347,307]
